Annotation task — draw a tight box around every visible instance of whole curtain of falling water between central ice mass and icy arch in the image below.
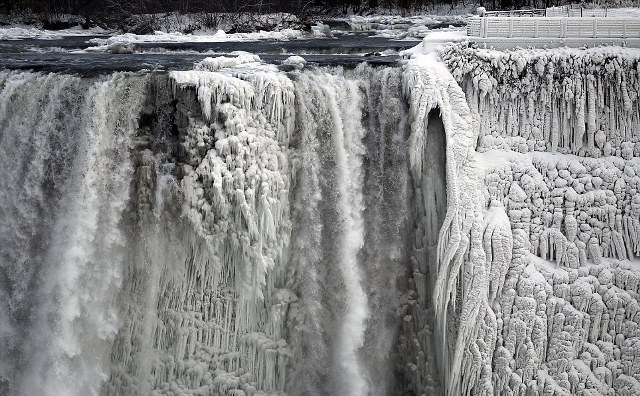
[293,67,407,395]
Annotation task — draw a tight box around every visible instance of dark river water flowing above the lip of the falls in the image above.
[0,32,419,75]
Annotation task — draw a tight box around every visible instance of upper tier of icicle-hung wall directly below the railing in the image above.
[443,43,640,158]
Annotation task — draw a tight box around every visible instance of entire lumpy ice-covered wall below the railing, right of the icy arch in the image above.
[442,44,640,395]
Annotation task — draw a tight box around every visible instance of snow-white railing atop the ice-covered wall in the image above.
[467,17,640,39]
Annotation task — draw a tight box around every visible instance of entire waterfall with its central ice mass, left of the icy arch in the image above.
[0,56,448,396]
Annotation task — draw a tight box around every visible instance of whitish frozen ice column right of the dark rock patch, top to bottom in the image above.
[166,64,295,395]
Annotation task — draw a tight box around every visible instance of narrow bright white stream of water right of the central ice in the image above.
[318,69,369,395]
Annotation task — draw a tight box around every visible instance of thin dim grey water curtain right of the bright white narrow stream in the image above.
[361,67,410,395]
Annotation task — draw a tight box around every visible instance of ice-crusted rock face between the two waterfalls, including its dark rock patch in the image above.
[102,61,297,396]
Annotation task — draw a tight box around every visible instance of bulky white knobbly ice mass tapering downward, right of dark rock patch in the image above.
[171,57,293,299]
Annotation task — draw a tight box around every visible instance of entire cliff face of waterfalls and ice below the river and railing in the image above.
[0,43,640,396]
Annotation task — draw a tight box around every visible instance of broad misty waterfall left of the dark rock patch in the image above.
[0,69,145,395]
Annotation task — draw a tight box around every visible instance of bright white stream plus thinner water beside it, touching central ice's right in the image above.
[294,69,368,394]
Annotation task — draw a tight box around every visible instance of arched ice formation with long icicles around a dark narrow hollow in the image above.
[399,53,488,395]
